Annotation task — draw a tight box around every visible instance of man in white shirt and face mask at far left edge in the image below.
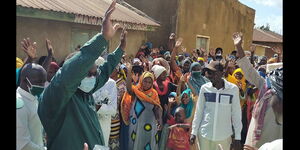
[16,63,47,150]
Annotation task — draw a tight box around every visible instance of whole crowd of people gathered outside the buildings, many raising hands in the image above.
[16,1,283,150]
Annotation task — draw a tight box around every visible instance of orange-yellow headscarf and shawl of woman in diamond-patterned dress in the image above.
[121,71,162,125]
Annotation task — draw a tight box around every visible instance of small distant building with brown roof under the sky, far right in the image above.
[252,29,282,58]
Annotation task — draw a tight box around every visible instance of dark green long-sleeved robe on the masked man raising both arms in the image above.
[38,34,123,150]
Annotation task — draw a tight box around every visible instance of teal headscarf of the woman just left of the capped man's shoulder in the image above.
[190,62,209,95]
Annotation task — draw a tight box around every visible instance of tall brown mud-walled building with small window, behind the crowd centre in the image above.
[125,0,255,54]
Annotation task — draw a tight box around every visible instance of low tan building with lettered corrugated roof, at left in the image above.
[16,0,160,62]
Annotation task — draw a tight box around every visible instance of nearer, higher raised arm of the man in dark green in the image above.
[38,1,118,118]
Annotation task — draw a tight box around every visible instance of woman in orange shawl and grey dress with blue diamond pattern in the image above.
[121,69,162,150]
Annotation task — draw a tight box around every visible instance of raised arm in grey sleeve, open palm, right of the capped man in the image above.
[233,33,265,89]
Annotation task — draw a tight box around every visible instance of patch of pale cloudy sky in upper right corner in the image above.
[239,0,283,34]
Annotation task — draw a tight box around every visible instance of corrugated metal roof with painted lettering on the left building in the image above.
[17,0,159,26]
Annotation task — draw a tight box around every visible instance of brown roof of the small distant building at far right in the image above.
[253,29,282,43]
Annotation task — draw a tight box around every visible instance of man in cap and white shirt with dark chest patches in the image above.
[190,61,242,150]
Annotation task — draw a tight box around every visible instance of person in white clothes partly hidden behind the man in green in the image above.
[93,57,118,146]
